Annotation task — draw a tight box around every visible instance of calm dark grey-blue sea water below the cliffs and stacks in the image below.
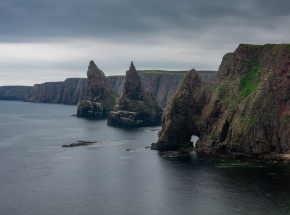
[0,101,290,215]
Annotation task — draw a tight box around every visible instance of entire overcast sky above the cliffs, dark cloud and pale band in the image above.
[0,0,290,86]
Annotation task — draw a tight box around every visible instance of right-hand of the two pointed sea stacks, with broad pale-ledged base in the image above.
[108,62,162,126]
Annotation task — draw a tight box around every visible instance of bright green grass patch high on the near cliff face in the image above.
[240,61,261,98]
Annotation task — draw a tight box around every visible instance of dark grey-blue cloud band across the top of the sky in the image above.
[0,0,290,41]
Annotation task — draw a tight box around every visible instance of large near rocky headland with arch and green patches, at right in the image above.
[152,44,290,156]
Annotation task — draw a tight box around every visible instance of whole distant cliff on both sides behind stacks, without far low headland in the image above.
[27,70,217,108]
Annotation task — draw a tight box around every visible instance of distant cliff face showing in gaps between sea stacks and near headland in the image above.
[109,70,216,108]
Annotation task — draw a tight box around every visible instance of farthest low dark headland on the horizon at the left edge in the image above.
[0,86,32,100]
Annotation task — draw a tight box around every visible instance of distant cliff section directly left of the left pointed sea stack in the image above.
[26,78,87,104]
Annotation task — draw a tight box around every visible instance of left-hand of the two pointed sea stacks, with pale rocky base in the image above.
[77,61,119,118]
